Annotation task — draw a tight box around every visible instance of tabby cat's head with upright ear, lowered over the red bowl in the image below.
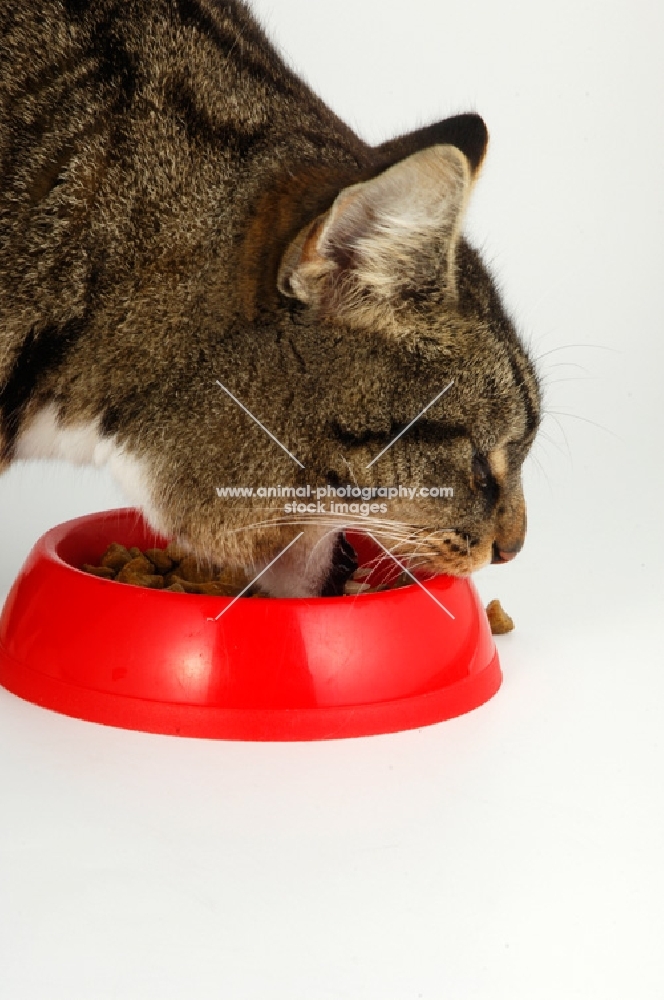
[236,115,540,574]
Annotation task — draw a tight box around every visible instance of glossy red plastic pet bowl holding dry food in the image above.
[0,509,502,740]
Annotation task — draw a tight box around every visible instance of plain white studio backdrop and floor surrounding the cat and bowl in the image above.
[0,0,664,1000]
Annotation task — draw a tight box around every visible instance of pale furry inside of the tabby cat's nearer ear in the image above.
[278,145,472,326]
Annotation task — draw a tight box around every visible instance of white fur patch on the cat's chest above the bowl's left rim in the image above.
[15,403,168,534]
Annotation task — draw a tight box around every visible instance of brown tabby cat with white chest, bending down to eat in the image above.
[0,0,541,597]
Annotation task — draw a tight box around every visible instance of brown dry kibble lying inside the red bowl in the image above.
[82,542,412,597]
